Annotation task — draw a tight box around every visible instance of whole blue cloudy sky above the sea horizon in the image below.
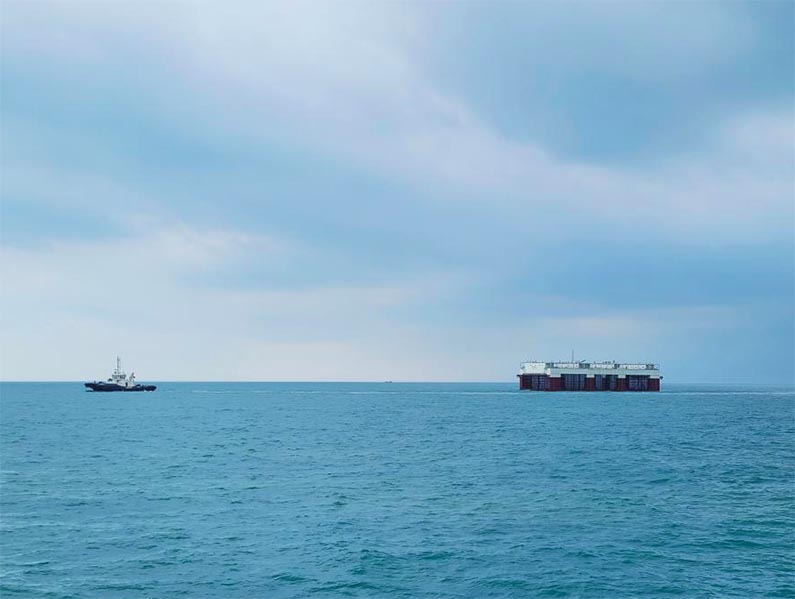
[0,0,795,384]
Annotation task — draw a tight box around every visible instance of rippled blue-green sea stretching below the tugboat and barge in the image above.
[0,382,795,599]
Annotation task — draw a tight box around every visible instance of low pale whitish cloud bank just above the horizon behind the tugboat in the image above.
[0,223,472,380]
